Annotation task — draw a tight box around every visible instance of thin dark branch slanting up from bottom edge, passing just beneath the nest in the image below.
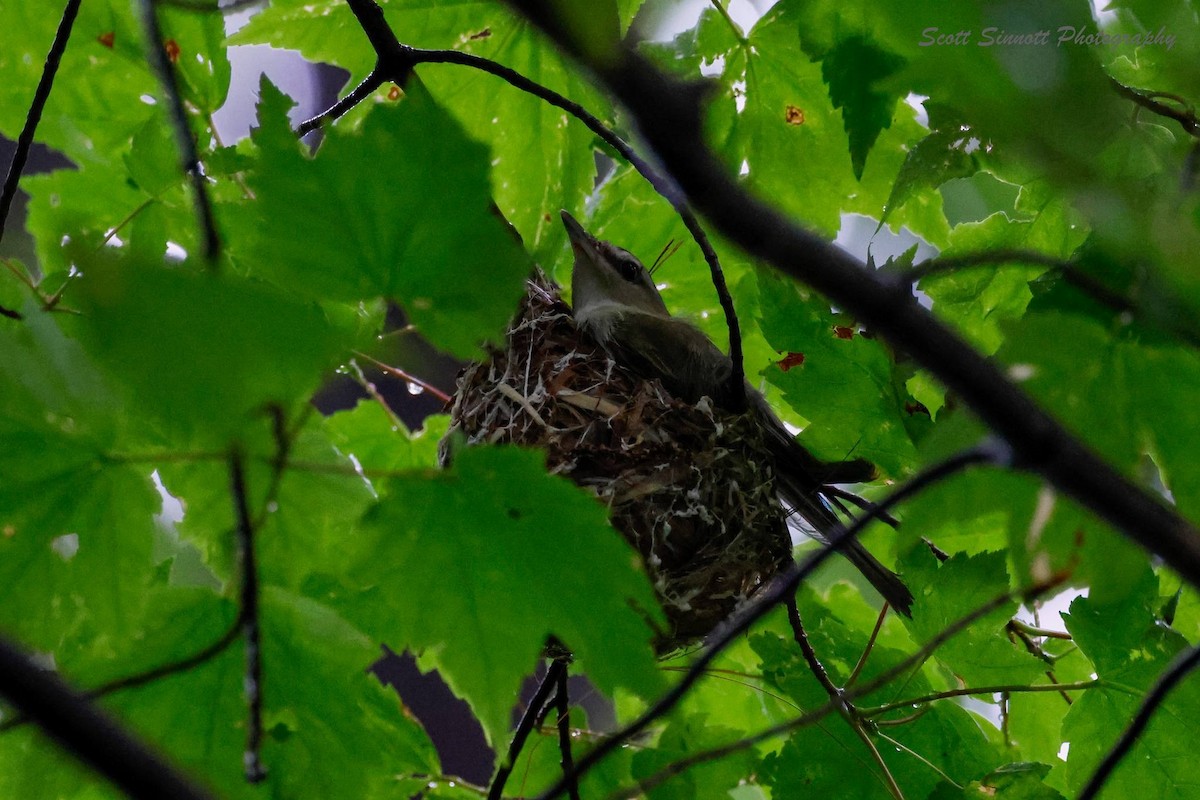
[539,446,1003,800]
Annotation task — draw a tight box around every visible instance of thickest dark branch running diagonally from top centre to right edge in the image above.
[501,0,1200,587]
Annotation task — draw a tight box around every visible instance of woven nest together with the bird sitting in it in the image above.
[441,211,912,650]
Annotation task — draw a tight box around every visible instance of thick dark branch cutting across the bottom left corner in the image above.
[0,638,210,800]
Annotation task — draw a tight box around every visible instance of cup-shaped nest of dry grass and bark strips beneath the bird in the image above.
[448,276,792,651]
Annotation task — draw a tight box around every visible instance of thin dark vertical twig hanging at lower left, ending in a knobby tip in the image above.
[229,452,266,783]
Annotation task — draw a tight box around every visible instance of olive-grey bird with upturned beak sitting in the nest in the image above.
[560,210,913,615]
